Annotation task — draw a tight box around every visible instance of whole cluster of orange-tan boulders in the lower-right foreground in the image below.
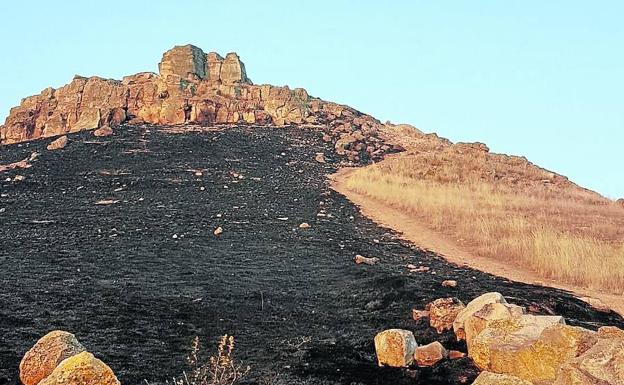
[375,293,624,385]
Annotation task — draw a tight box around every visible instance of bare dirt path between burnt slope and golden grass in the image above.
[331,168,624,315]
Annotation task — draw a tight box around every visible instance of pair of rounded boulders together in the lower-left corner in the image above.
[20,330,120,385]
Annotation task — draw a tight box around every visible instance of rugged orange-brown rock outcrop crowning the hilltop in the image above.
[0,45,396,161]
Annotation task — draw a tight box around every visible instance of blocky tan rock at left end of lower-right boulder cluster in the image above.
[375,329,417,368]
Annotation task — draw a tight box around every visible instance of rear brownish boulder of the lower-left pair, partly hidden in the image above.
[20,330,85,385]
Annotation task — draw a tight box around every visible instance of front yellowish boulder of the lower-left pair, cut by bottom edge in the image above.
[39,352,120,385]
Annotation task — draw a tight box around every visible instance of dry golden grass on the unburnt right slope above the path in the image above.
[346,150,624,294]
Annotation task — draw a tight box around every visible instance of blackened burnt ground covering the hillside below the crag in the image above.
[0,127,624,385]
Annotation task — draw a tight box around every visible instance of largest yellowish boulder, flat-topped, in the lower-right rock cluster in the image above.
[468,315,597,382]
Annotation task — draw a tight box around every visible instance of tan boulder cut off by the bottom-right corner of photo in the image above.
[553,338,624,385]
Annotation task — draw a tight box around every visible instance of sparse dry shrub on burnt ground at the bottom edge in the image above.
[173,334,250,385]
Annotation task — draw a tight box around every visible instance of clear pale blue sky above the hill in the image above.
[0,0,624,198]
